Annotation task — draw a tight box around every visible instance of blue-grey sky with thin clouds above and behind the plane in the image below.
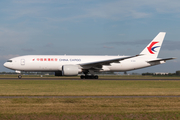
[0,0,180,73]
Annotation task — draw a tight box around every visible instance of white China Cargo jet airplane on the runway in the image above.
[4,32,175,79]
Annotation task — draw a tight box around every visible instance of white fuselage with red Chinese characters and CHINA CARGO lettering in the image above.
[4,55,161,72]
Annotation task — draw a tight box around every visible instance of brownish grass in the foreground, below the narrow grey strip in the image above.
[0,98,180,120]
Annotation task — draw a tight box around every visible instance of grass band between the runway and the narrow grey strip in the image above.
[0,79,180,96]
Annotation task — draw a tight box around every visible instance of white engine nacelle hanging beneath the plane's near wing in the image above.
[62,65,80,76]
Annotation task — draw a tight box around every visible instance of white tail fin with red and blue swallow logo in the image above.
[140,32,166,58]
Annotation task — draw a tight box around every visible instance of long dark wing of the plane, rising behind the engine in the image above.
[79,55,140,68]
